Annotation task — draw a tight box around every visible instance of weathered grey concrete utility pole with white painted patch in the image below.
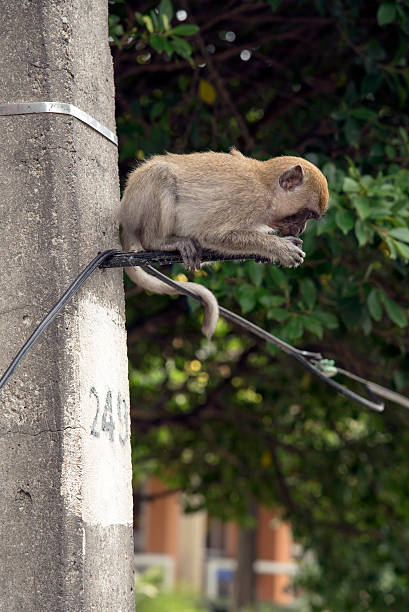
[0,0,134,612]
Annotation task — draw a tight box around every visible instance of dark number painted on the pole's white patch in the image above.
[89,387,129,446]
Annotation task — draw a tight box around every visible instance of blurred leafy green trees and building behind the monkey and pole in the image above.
[109,0,409,612]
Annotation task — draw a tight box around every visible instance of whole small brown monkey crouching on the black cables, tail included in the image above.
[120,148,329,338]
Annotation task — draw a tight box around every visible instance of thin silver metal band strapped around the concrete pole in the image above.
[0,102,118,146]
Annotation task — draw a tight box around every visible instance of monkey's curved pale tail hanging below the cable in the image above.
[122,233,219,339]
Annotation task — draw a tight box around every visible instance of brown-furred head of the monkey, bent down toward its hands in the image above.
[264,156,329,236]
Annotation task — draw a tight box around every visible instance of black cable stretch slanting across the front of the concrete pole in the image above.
[0,249,121,390]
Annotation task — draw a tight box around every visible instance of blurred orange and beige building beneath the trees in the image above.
[135,478,296,606]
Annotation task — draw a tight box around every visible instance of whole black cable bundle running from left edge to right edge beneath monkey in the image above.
[0,249,409,412]
